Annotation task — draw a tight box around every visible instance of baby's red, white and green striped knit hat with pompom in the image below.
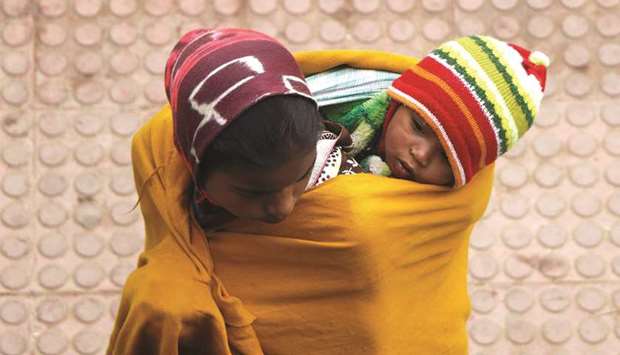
[386,36,549,187]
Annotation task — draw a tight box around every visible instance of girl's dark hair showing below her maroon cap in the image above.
[186,95,323,206]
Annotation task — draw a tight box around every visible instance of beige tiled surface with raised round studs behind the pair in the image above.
[0,0,620,354]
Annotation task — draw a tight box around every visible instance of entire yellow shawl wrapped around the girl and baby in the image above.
[108,51,493,355]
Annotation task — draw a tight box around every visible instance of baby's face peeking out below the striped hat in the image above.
[385,105,454,186]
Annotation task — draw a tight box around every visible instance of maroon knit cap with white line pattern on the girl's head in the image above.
[164,28,314,199]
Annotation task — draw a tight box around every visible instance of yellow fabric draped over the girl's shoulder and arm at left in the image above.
[108,106,262,355]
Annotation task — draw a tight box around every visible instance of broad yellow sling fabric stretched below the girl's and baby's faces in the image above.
[209,168,493,355]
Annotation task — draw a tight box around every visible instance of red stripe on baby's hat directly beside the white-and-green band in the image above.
[418,57,497,165]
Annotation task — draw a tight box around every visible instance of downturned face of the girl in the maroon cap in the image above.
[204,149,316,223]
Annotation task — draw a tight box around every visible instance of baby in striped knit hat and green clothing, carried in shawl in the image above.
[309,36,549,187]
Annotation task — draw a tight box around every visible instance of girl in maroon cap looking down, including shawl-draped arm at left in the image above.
[108,29,357,354]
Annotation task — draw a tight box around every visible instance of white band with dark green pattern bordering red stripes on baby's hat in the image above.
[433,47,508,155]
